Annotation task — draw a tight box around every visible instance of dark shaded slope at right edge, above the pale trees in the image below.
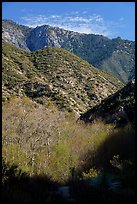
[80,80,135,125]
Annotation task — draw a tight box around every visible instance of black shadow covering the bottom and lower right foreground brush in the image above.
[2,124,135,203]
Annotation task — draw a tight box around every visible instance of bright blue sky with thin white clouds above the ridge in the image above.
[2,2,135,40]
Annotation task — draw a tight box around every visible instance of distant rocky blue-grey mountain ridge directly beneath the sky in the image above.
[2,20,135,83]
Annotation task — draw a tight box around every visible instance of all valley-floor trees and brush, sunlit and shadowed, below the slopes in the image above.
[2,97,135,201]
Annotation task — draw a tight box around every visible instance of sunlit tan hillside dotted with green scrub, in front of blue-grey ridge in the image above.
[2,42,123,114]
